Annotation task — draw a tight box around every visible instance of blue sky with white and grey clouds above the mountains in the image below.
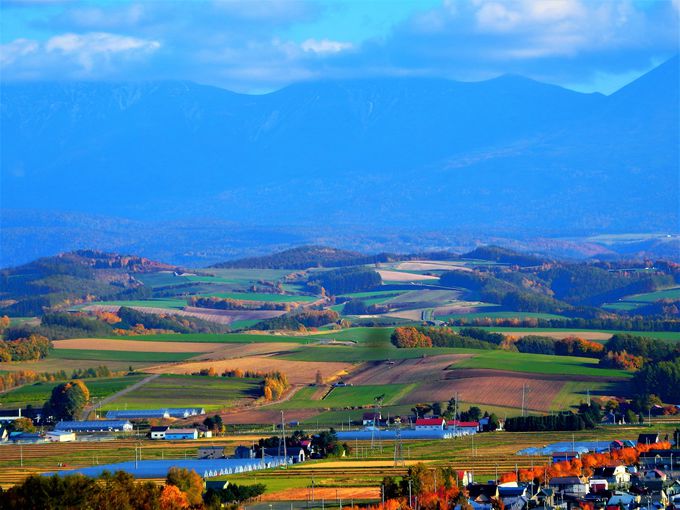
[0,0,680,93]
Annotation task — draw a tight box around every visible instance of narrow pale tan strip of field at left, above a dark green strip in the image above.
[52,338,224,353]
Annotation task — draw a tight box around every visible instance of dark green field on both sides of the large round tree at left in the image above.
[0,375,144,407]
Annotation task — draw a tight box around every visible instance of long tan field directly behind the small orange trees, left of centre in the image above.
[148,356,352,384]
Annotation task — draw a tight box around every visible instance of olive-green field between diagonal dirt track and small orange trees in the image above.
[104,375,261,410]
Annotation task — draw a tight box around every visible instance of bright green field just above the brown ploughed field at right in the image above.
[449,349,632,378]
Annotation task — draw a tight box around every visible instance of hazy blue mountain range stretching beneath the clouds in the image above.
[0,57,680,234]
